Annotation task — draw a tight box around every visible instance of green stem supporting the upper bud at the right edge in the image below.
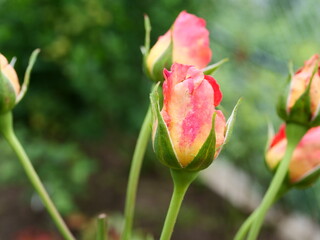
[248,124,308,240]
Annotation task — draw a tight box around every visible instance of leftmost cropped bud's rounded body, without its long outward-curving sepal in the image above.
[0,54,20,113]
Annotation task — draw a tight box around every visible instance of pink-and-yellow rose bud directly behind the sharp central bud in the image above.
[145,11,211,82]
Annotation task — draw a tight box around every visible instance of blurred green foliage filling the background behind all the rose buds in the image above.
[0,0,320,234]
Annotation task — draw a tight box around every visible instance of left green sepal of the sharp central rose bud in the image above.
[150,83,182,169]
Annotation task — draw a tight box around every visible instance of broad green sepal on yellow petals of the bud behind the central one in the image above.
[149,30,173,83]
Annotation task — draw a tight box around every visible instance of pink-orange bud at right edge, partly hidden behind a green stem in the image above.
[266,125,320,186]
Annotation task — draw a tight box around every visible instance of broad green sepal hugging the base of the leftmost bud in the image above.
[0,71,16,114]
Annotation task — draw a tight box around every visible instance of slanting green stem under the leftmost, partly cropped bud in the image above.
[0,112,75,240]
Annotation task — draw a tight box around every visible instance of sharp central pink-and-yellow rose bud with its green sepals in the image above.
[151,63,236,171]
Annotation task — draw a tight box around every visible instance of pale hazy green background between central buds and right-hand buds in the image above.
[202,0,320,221]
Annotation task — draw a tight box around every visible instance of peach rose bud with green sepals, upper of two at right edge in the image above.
[278,54,320,127]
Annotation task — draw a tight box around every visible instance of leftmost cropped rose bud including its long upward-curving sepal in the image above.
[0,49,40,114]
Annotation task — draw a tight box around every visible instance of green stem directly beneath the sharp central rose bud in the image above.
[160,169,198,240]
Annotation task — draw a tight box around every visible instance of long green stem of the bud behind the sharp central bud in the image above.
[121,107,151,240]
